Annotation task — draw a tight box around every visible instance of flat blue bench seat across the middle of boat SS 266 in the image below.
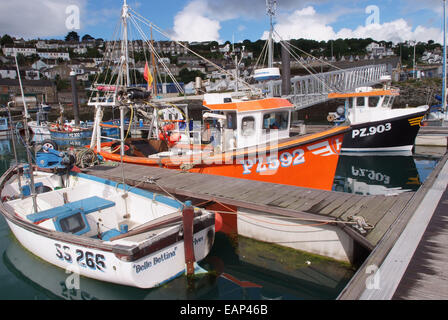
[26,196,115,223]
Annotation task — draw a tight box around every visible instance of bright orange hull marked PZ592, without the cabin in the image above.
[94,127,349,190]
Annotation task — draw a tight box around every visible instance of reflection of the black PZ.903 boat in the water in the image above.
[333,151,423,195]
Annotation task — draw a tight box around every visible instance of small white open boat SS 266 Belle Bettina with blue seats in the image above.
[0,160,215,288]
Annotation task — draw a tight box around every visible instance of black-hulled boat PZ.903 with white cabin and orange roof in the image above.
[327,82,429,152]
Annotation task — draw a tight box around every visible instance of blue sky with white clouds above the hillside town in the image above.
[0,0,443,43]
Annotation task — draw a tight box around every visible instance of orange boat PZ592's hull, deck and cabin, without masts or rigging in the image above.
[94,94,350,190]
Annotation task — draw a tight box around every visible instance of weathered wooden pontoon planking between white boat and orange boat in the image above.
[85,164,418,247]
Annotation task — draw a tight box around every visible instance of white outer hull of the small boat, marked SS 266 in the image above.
[7,219,214,288]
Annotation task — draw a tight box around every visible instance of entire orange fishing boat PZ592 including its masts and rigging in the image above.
[84,3,350,190]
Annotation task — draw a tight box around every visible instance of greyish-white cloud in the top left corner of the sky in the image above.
[0,0,86,39]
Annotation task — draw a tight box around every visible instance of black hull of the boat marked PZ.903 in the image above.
[342,111,426,152]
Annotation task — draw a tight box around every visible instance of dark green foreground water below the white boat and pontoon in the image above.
[0,233,353,300]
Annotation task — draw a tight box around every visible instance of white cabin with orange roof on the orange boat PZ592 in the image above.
[203,93,294,151]
